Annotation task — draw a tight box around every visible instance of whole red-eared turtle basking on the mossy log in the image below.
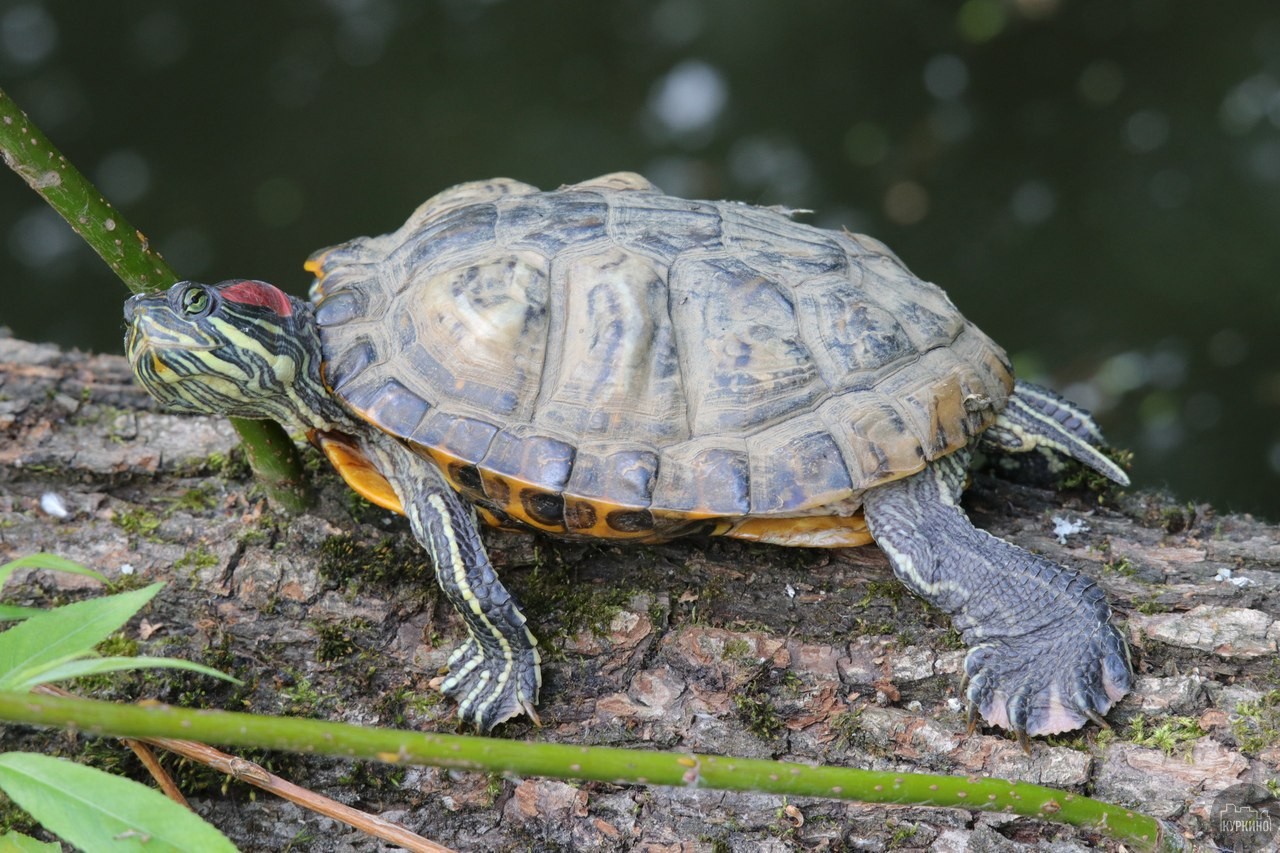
[124,173,1133,745]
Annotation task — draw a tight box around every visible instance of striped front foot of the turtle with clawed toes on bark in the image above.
[431,638,543,731]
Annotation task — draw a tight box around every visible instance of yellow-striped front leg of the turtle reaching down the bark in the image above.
[375,440,543,731]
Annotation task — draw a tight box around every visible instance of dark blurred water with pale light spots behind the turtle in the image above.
[0,0,1280,519]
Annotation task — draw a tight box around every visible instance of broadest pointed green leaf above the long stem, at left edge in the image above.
[0,584,164,689]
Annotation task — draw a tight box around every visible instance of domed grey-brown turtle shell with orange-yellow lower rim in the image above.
[307,173,1012,538]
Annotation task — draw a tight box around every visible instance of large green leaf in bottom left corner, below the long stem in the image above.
[0,752,236,853]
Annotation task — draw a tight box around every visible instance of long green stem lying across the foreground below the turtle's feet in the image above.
[0,693,1181,850]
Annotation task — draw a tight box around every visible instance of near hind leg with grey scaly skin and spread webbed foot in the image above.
[864,452,1132,748]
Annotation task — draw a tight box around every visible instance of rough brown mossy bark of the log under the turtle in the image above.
[0,327,1280,850]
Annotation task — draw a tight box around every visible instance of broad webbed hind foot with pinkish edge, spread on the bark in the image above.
[965,624,1133,743]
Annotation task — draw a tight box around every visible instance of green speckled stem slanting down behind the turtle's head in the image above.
[0,90,310,512]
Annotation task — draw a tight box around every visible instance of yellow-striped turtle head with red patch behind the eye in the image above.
[124,280,328,425]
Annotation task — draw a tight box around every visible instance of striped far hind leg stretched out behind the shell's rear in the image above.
[982,380,1129,485]
